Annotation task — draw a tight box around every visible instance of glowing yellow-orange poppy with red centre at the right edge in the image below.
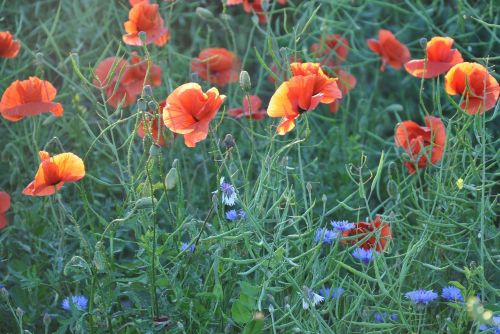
[444,63,500,115]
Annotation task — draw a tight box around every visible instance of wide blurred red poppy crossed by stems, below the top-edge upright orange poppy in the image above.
[94,52,161,108]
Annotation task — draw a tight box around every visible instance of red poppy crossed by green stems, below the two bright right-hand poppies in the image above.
[394,116,446,174]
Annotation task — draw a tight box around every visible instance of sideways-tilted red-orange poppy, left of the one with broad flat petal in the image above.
[367,29,410,72]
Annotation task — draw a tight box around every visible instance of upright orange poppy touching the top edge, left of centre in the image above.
[123,1,169,46]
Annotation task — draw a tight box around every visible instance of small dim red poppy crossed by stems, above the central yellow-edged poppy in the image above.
[311,34,349,67]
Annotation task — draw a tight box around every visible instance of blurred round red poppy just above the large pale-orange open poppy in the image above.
[191,48,241,87]
